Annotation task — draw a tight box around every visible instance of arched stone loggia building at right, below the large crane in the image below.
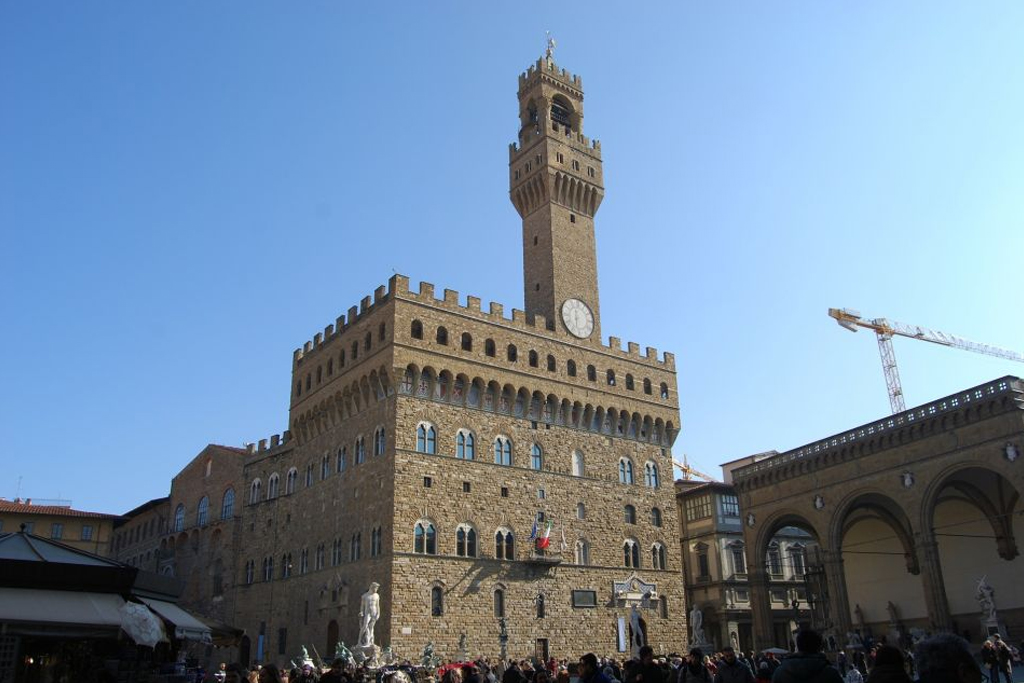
[729,377,1024,647]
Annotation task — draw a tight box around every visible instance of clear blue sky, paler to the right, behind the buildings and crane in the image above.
[0,0,1024,513]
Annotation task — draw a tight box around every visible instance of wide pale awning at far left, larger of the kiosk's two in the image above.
[0,588,125,629]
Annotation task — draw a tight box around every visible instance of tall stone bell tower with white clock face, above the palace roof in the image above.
[509,57,604,340]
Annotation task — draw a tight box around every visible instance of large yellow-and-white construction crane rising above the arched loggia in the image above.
[828,308,1024,415]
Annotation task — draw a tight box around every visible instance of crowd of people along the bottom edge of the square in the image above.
[206,630,1014,683]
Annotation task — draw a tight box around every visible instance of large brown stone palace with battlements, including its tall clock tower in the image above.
[228,58,686,661]
